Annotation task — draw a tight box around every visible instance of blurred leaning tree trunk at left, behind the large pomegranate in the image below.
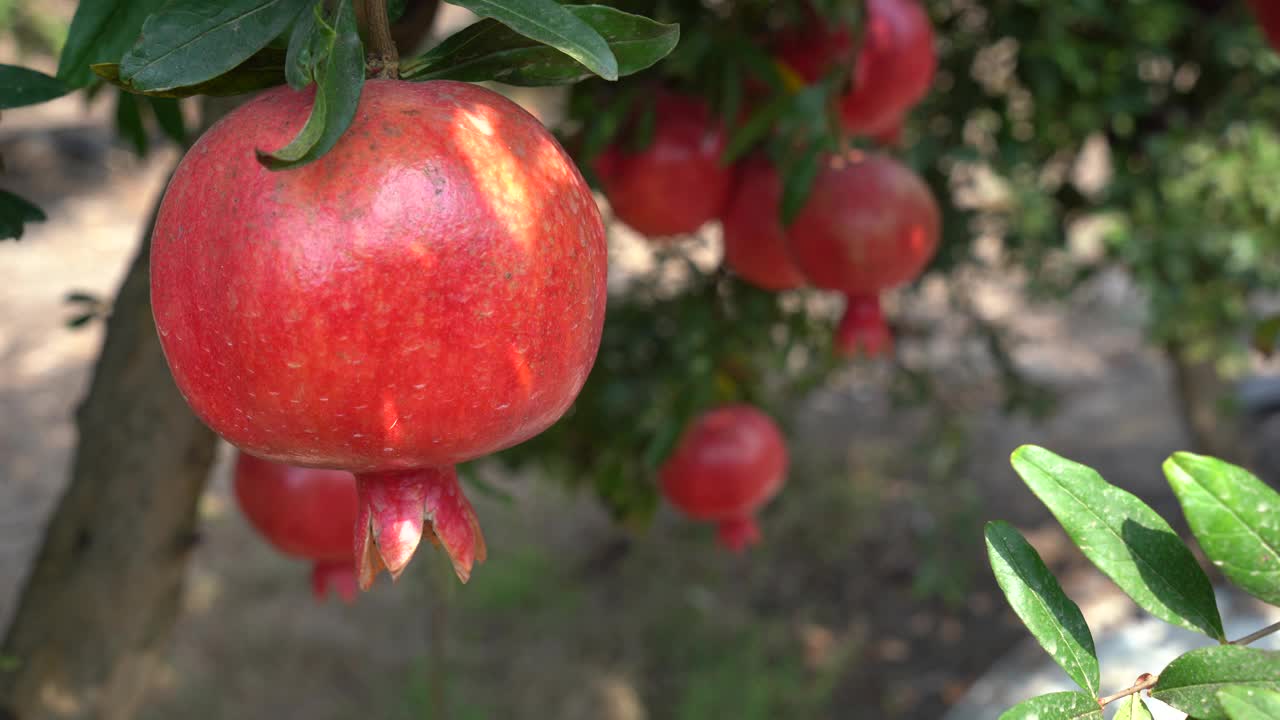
[0,200,214,720]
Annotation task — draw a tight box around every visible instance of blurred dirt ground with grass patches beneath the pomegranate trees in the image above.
[0,50,1274,720]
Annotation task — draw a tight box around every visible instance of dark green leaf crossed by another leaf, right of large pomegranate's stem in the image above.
[401,5,680,87]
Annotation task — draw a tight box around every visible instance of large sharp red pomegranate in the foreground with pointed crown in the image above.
[151,79,607,588]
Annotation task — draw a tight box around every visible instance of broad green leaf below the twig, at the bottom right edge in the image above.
[1151,644,1280,720]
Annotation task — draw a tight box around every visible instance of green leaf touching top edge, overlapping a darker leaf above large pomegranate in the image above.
[449,0,618,79]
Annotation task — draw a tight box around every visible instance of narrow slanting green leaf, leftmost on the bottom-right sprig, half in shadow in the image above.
[986,521,1101,696]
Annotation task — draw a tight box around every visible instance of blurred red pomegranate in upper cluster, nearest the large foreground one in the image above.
[595,92,732,238]
